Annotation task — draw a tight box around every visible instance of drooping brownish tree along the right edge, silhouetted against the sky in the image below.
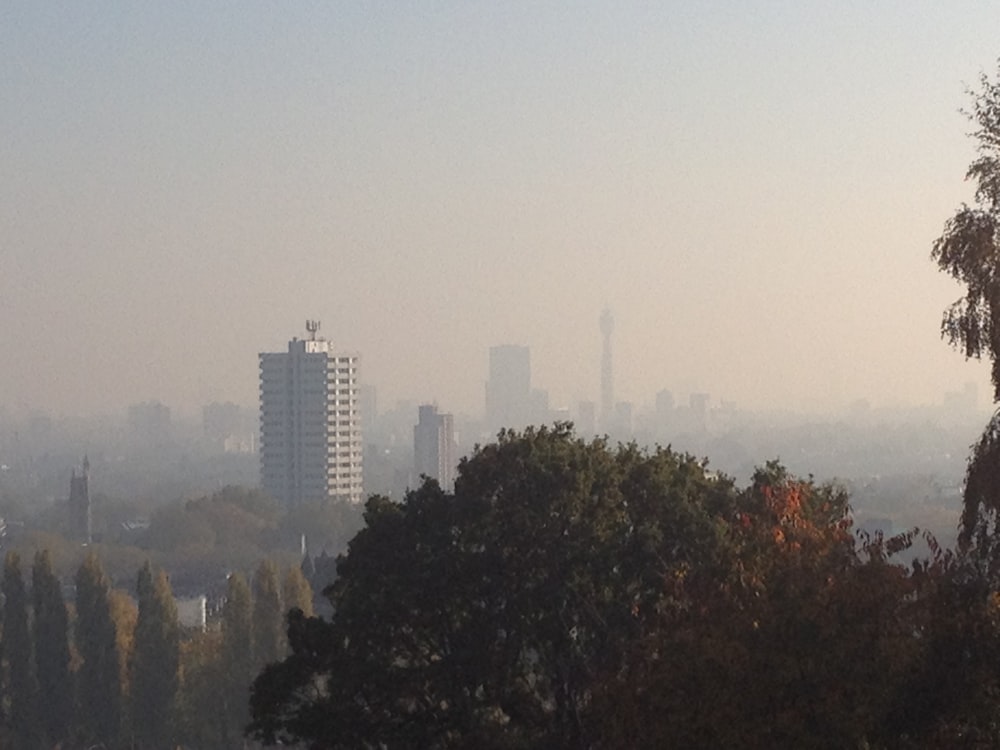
[931,58,1000,545]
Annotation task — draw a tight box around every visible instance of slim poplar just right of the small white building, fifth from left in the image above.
[222,573,254,748]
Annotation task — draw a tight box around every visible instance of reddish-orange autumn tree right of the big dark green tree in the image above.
[595,464,921,748]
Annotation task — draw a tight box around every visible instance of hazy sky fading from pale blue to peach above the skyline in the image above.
[0,0,1000,414]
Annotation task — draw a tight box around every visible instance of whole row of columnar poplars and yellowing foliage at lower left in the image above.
[0,550,313,750]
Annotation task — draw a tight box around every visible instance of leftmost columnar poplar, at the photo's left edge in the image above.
[0,552,37,748]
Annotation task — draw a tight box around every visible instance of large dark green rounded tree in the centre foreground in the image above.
[252,425,735,748]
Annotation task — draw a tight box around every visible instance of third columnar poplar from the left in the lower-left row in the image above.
[74,553,123,748]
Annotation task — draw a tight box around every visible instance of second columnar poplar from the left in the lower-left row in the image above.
[31,550,73,747]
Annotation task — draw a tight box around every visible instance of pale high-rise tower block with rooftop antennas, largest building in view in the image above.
[260,321,362,506]
